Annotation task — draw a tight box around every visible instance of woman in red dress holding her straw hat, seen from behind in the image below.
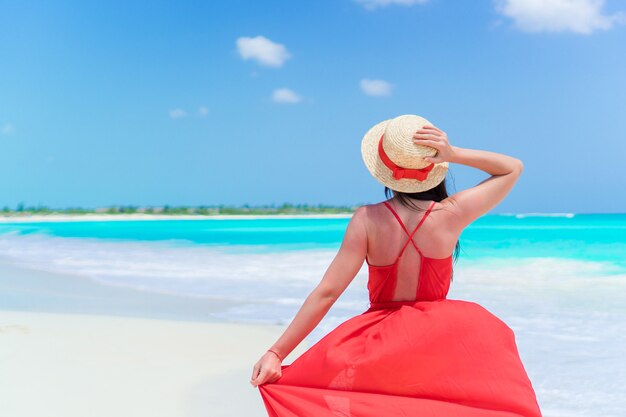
[250,115,541,417]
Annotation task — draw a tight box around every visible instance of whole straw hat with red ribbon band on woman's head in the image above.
[361,114,448,193]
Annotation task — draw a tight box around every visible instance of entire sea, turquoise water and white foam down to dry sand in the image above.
[0,213,626,417]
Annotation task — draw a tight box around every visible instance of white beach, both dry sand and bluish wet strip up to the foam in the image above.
[0,257,308,417]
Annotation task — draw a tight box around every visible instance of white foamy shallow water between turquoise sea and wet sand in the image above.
[0,228,626,417]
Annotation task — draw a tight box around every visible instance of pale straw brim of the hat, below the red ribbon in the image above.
[361,119,448,193]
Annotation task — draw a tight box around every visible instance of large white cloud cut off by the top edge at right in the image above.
[496,0,626,34]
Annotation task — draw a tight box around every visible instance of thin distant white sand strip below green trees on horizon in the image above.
[0,213,352,223]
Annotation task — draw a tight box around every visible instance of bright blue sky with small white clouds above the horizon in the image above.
[0,0,626,212]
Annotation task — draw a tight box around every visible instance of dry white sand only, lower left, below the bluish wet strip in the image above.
[0,310,306,417]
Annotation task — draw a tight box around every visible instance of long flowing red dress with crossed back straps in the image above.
[258,202,541,417]
